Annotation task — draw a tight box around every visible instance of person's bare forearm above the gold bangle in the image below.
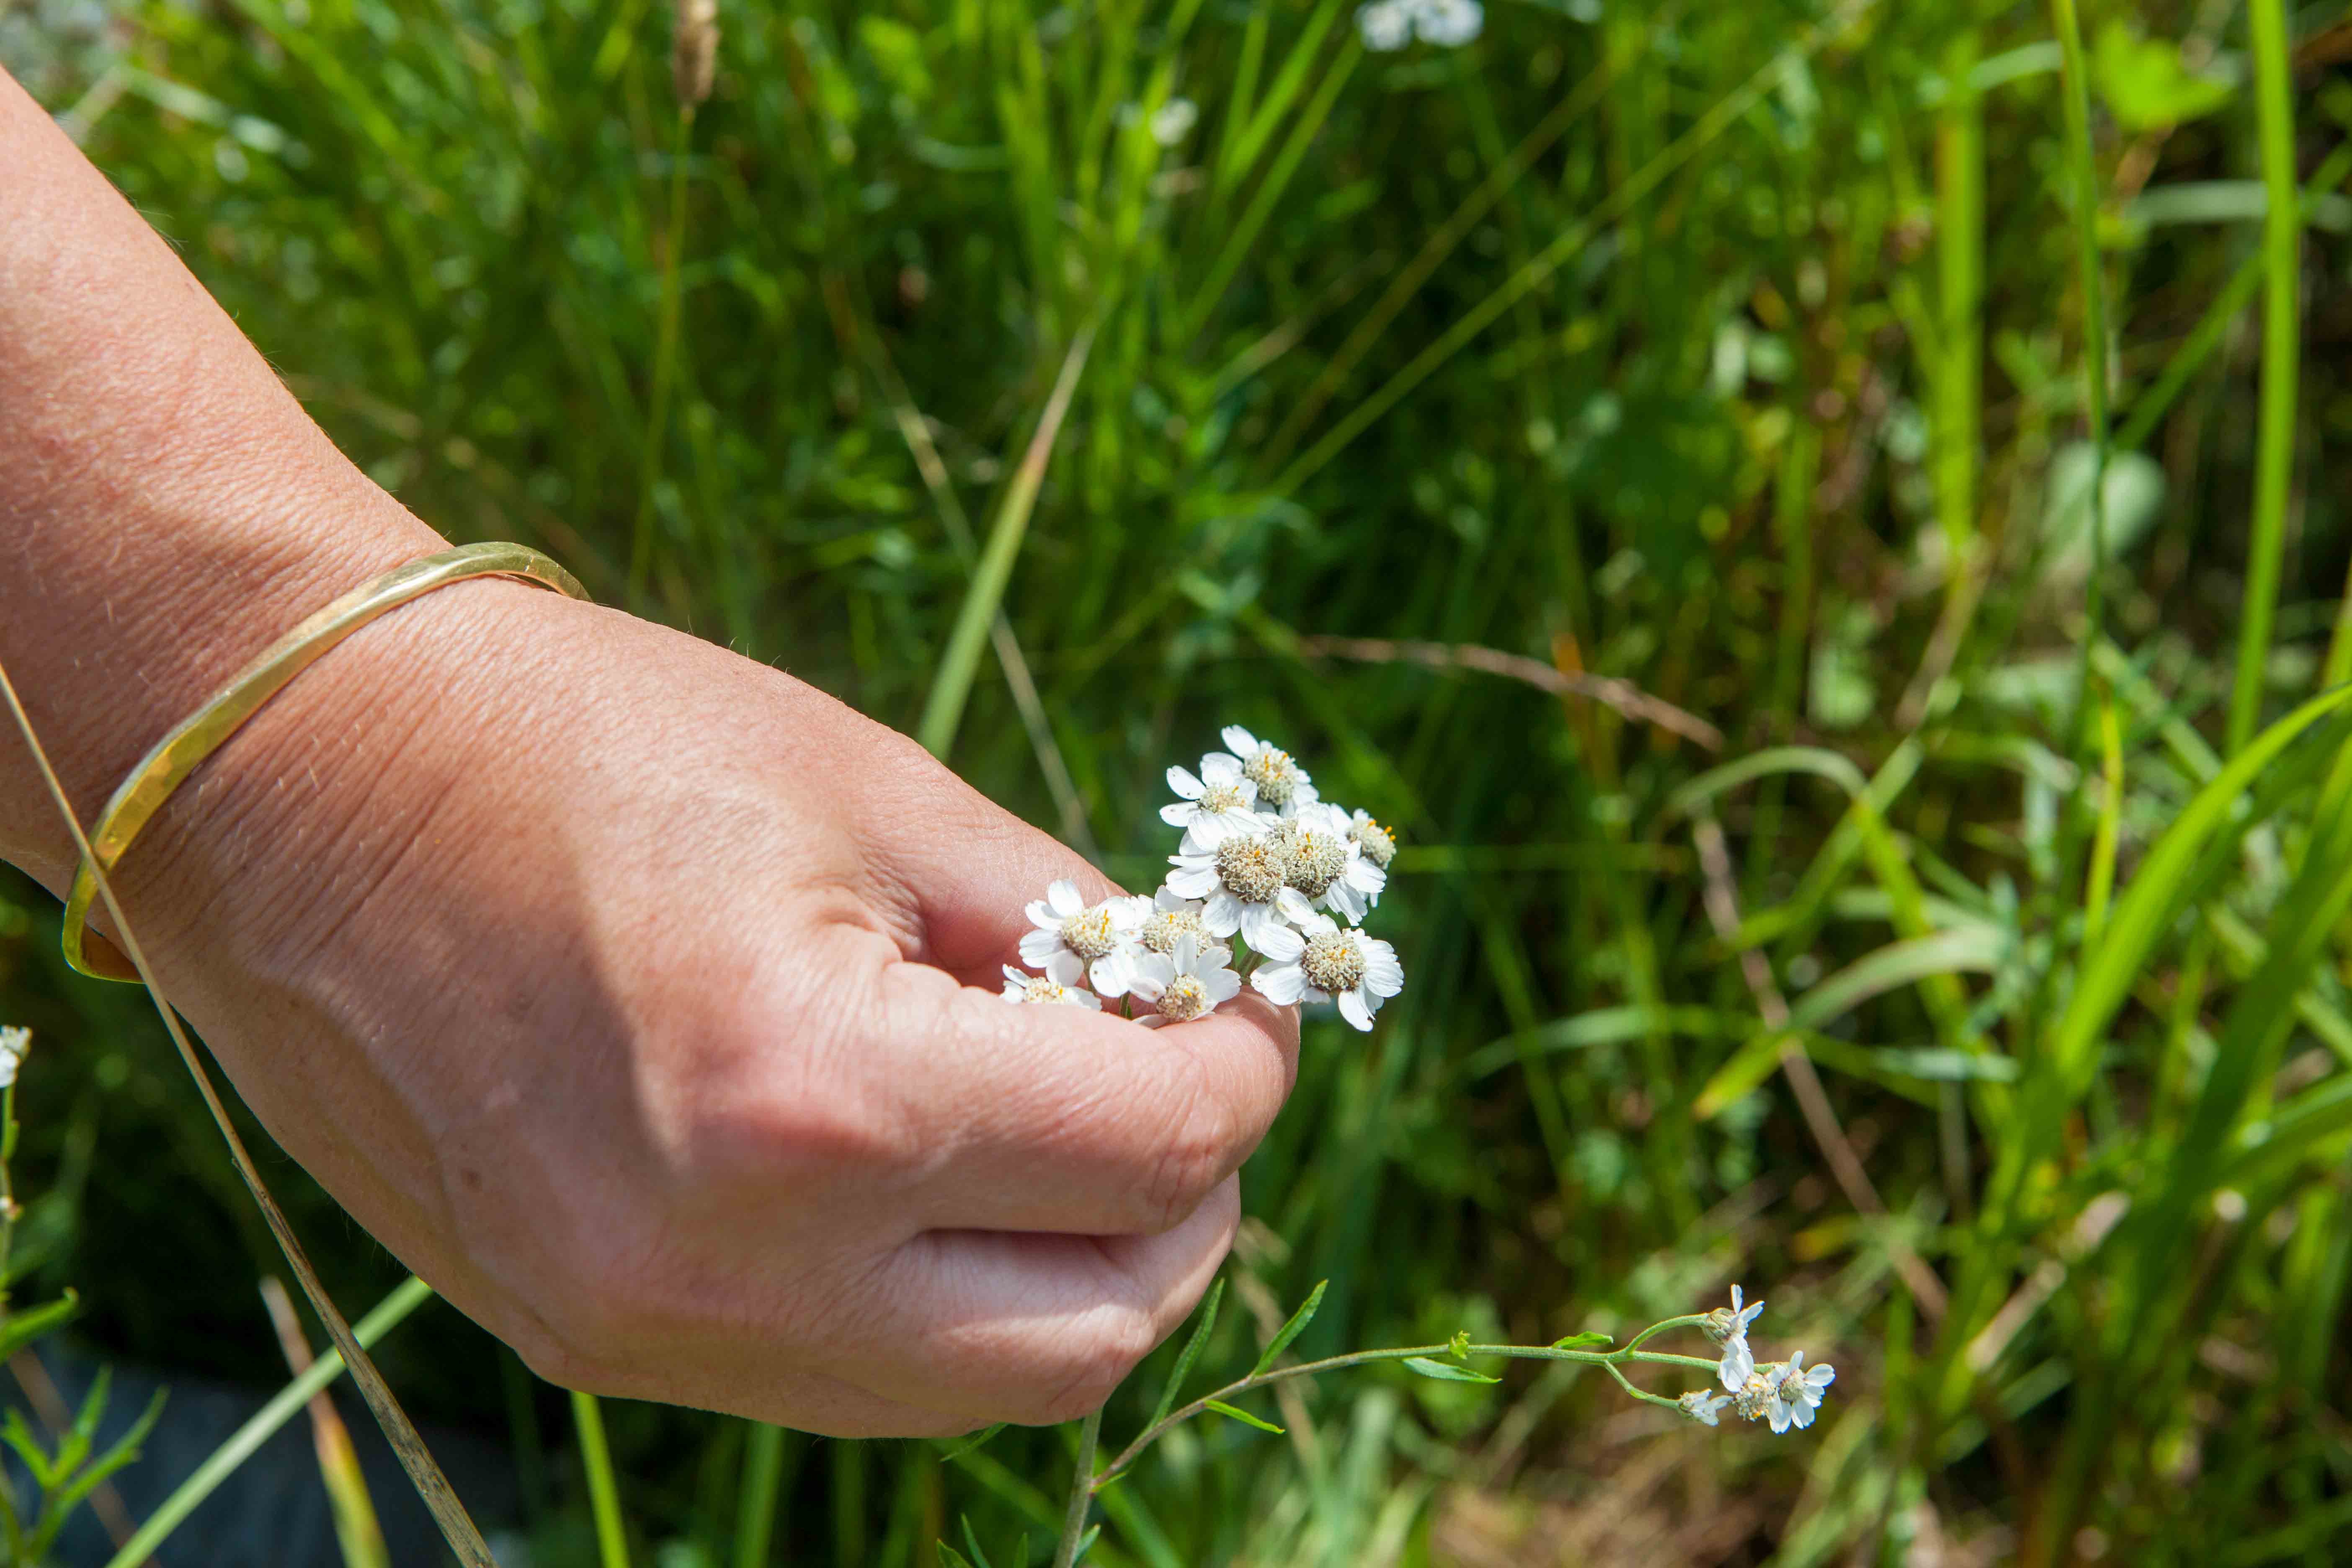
[0,73,440,886]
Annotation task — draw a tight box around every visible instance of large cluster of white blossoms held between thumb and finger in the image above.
[1004,724,1404,1030]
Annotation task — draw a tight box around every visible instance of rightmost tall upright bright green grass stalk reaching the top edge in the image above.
[2227,0,2303,755]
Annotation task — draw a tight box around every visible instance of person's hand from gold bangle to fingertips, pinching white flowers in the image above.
[101,580,1296,1436]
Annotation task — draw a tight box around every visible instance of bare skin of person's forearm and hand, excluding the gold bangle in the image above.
[0,73,1296,1436]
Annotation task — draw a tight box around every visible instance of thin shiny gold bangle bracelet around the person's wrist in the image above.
[61,543,588,983]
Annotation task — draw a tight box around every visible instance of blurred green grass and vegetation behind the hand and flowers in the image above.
[0,0,2352,1568]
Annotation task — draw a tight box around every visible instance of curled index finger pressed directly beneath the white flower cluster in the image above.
[882,964,1298,1237]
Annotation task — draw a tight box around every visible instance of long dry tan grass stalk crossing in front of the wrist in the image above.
[0,665,499,1568]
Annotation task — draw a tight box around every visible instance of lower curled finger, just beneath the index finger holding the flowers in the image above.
[861,1178,1242,1425]
